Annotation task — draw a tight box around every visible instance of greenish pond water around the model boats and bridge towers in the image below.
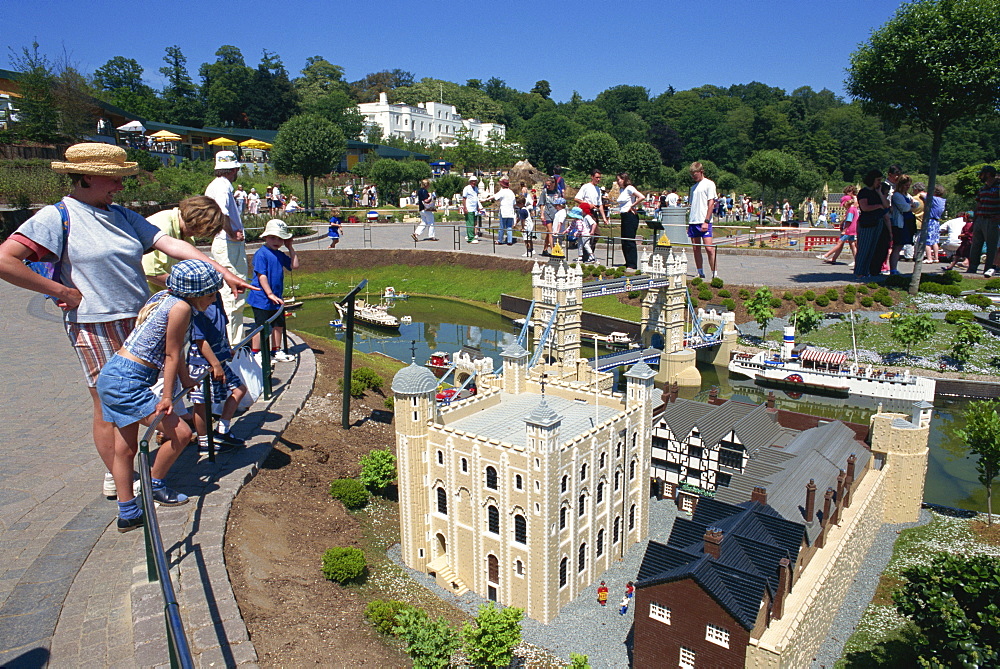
[289,297,1000,511]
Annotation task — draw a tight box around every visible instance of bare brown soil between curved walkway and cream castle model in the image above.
[225,338,409,667]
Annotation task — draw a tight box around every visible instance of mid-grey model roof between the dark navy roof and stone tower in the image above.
[720,421,871,544]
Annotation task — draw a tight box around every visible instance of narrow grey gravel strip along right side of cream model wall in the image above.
[812,509,931,669]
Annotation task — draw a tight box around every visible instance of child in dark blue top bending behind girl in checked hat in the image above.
[188,295,247,454]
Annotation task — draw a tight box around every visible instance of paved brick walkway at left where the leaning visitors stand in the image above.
[0,282,316,668]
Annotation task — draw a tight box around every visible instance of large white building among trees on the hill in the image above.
[358,93,507,146]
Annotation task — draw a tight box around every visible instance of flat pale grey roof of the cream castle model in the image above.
[446,393,622,446]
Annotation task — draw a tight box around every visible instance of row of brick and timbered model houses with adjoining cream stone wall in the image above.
[634,393,932,668]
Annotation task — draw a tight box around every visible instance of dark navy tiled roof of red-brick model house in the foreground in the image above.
[636,498,804,630]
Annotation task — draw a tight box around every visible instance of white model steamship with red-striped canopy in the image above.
[729,326,935,402]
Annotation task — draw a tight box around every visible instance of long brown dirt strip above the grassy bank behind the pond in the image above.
[297,249,531,274]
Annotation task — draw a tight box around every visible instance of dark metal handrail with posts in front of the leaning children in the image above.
[133,307,285,669]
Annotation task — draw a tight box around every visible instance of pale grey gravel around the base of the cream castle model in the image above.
[388,499,677,668]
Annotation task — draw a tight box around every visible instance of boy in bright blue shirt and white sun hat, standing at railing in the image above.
[247,218,299,362]
